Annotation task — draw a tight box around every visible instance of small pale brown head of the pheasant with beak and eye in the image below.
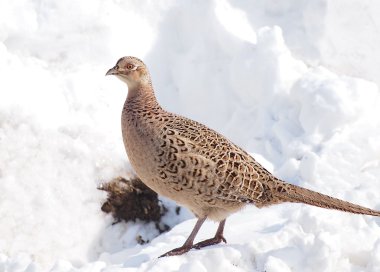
[106,57,150,89]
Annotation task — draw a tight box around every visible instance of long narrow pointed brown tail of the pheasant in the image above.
[275,182,380,216]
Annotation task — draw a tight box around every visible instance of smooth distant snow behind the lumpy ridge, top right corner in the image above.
[231,0,380,84]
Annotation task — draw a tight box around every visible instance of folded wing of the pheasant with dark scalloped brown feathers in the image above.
[162,112,277,206]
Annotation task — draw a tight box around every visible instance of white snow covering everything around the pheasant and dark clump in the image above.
[0,0,380,272]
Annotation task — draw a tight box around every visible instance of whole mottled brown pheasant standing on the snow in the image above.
[107,57,380,256]
